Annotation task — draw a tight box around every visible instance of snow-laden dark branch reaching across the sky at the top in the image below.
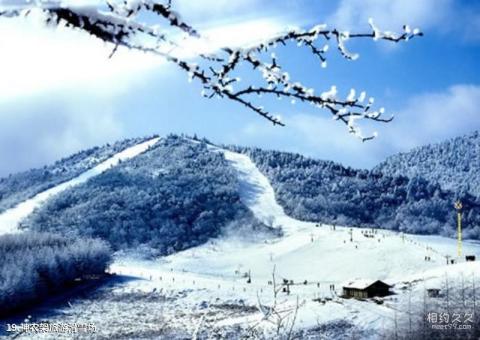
[0,0,422,141]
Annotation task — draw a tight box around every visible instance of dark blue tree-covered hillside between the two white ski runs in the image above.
[25,135,261,254]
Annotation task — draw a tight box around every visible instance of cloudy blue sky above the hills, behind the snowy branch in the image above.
[0,0,480,175]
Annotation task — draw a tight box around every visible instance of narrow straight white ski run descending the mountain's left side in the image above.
[0,137,160,235]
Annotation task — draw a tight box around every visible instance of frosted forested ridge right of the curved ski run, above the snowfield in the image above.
[230,146,480,239]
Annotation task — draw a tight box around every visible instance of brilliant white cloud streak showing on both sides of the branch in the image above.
[0,5,290,103]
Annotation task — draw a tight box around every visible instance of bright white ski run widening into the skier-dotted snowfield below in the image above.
[112,146,480,335]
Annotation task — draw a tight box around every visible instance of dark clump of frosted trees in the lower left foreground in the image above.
[0,232,112,317]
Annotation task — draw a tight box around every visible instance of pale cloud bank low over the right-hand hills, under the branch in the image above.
[236,84,480,168]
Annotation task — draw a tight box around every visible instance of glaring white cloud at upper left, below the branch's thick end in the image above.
[0,11,163,103]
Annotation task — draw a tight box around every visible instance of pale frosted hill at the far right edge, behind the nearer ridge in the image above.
[374,131,480,196]
